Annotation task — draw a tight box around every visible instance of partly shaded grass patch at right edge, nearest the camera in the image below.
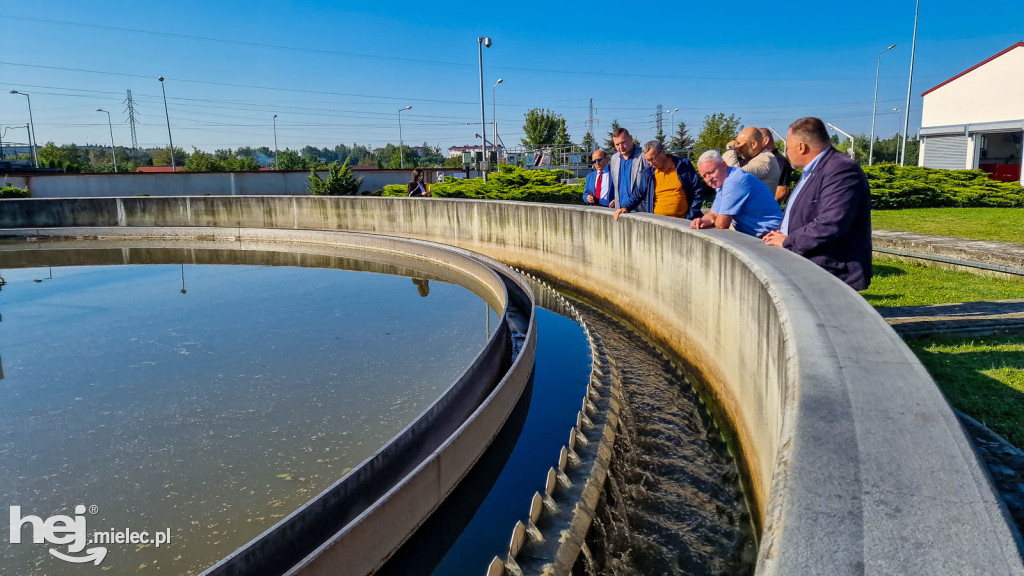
[907,335,1024,448]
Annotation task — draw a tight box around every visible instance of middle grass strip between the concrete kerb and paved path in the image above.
[861,256,1024,306]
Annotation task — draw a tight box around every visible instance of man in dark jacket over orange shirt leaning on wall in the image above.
[615,140,707,220]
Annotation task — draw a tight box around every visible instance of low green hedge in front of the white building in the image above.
[863,164,1024,210]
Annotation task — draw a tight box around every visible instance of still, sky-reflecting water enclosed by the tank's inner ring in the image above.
[0,250,494,574]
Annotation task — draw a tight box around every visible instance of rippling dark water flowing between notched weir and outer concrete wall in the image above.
[575,304,757,576]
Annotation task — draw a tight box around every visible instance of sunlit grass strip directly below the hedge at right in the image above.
[871,208,1024,244]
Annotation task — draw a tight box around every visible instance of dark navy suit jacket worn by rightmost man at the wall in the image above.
[782,147,871,290]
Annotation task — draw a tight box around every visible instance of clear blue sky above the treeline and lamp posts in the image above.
[0,0,1024,152]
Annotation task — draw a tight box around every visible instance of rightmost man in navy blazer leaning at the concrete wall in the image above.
[764,118,871,290]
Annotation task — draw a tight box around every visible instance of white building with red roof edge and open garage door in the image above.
[919,42,1024,186]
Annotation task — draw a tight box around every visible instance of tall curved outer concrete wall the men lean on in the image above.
[0,197,1024,575]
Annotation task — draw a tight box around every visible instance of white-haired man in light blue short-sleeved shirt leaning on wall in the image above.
[690,150,782,238]
